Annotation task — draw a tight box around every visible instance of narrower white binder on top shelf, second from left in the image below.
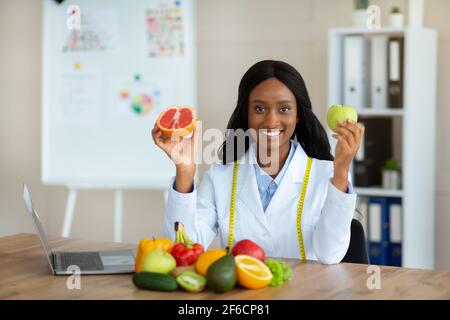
[370,35,389,109]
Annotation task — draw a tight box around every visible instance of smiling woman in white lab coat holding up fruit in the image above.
[152,60,364,264]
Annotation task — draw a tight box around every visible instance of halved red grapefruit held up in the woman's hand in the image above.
[156,106,195,138]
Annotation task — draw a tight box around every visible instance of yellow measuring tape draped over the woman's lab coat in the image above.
[228,157,312,261]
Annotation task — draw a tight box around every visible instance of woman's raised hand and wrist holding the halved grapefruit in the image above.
[152,121,199,192]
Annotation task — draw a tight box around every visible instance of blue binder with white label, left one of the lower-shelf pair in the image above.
[368,197,389,265]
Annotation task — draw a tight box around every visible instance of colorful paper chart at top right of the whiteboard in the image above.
[145,0,185,58]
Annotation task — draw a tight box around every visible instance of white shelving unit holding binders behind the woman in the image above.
[328,28,437,269]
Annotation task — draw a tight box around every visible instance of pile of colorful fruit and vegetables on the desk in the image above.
[133,222,292,293]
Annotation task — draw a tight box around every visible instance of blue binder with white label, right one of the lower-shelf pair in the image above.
[389,198,402,267]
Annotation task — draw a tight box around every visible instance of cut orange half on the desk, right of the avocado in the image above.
[235,254,273,289]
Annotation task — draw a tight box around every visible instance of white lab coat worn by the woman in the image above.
[164,142,356,264]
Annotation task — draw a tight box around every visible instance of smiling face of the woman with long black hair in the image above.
[248,78,297,151]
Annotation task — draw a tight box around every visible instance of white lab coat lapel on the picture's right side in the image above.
[265,142,308,217]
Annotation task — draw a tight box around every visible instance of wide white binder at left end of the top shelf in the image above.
[343,36,370,109]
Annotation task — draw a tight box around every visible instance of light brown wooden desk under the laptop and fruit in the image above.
[0,234,450,300]
